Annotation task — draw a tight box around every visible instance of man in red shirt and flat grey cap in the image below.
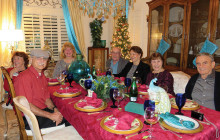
[14,49,69,130]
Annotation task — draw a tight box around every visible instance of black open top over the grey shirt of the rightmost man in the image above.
[185,72,220,111]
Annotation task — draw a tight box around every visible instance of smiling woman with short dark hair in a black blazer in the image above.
[114,46,150,84]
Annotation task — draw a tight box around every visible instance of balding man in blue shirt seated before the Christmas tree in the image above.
[106,47,128,74]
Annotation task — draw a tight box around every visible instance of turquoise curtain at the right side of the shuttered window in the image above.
[62,0,81,54]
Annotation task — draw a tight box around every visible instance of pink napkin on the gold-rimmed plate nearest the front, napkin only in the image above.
[105,109,135,130]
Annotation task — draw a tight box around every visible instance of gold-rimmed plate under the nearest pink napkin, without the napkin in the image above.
[100,115,143,134]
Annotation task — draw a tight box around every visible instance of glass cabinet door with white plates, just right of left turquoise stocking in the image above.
[166,3,184,67]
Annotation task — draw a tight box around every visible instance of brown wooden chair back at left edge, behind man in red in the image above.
[1,66,28,140]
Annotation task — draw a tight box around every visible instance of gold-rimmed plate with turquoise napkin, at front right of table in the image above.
[159,113,203,134]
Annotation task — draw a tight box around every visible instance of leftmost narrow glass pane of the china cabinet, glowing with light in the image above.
[149,6,164,55]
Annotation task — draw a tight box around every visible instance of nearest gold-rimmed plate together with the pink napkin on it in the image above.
[100,109,143,134]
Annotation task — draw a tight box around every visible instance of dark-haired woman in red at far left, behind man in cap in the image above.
[4,51,29,105]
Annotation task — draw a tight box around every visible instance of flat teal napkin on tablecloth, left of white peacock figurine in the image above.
[125,102,144,115]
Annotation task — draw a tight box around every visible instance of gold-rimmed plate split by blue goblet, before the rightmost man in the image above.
[170,98,200,110]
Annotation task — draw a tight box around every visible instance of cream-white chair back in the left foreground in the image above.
[13,96,43,140]
